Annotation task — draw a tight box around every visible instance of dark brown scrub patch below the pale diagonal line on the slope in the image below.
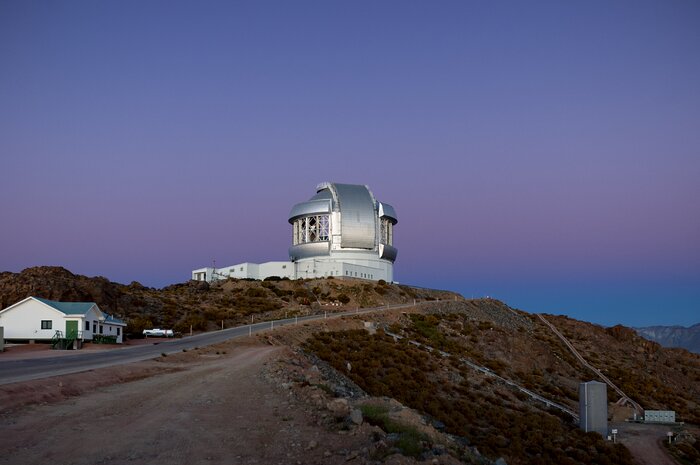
[306,330,633,465]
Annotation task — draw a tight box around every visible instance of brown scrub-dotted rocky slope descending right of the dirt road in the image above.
[268,299,700,465]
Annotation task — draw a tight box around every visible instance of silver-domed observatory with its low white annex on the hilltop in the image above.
[192,182,398,282]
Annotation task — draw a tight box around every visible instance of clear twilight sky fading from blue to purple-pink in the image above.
[0,0,700,326]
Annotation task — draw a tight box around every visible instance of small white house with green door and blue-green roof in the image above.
[0,297,126,344]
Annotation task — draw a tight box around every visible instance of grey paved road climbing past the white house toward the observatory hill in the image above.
[0,302,430,385]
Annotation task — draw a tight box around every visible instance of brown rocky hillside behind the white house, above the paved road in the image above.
[0,267,462,335]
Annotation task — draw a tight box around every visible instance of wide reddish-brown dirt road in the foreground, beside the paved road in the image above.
[0,345,366,465]
